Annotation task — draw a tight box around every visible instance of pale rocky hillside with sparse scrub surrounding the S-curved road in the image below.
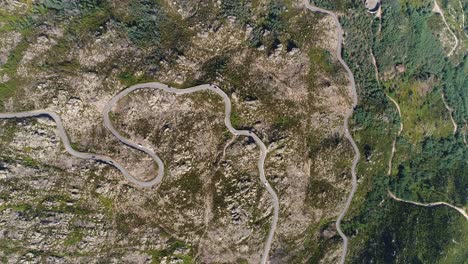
[0,1,352,263]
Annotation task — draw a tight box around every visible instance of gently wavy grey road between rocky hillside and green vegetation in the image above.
[304,0,361,264]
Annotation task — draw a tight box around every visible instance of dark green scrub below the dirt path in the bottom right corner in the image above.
[346,200,468,263]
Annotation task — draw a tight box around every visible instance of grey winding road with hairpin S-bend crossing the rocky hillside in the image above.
[0,82,279,264]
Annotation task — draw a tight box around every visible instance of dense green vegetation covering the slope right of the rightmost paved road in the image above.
[313,0,468,263]
